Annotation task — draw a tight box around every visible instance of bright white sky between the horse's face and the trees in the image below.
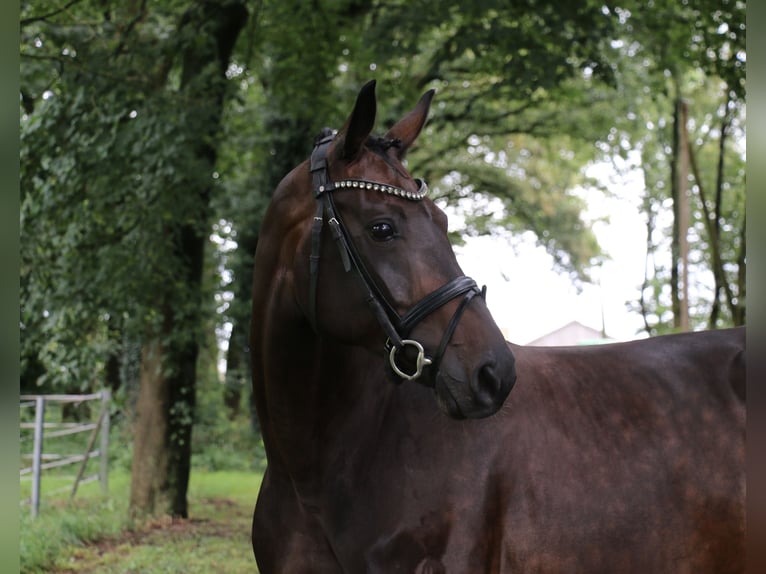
[455,159,646,344]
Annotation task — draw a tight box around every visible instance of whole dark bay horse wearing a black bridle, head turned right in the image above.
[251,83,745,574]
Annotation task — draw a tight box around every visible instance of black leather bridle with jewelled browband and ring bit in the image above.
[309,133,486,384]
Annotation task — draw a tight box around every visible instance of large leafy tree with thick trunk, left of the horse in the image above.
[21,0,247,516]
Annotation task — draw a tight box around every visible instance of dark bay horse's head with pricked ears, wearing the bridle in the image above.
[256,81,516,418]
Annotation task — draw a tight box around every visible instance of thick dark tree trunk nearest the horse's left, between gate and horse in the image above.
[130,1,247,518]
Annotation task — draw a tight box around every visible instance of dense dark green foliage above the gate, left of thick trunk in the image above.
[21,3,224,389]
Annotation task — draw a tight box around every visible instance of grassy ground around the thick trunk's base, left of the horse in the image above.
[20,470,261,574]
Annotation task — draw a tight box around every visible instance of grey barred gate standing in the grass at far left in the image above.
[19,390,111,518]
